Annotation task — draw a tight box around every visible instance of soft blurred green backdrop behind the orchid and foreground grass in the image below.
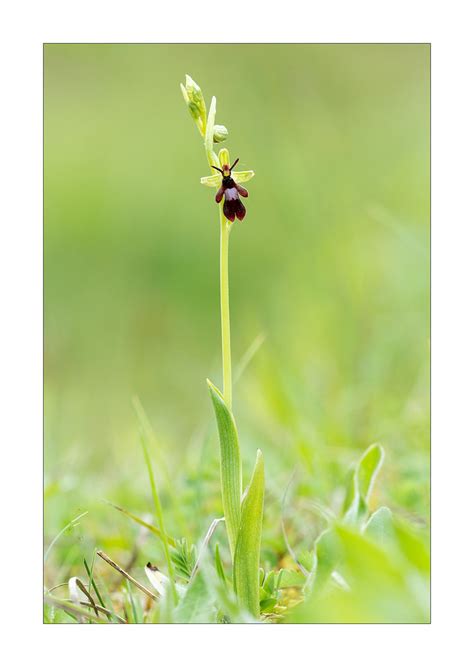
[44,44,430,600]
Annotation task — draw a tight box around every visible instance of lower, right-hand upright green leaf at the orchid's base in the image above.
[234,450,265,618]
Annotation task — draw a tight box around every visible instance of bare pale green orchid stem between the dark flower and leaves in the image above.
[219,206,232,411]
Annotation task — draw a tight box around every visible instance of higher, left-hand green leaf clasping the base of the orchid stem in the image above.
[207,380,242,556]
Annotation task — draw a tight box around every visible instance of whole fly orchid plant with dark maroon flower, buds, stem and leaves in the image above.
[181,75,264,618]
